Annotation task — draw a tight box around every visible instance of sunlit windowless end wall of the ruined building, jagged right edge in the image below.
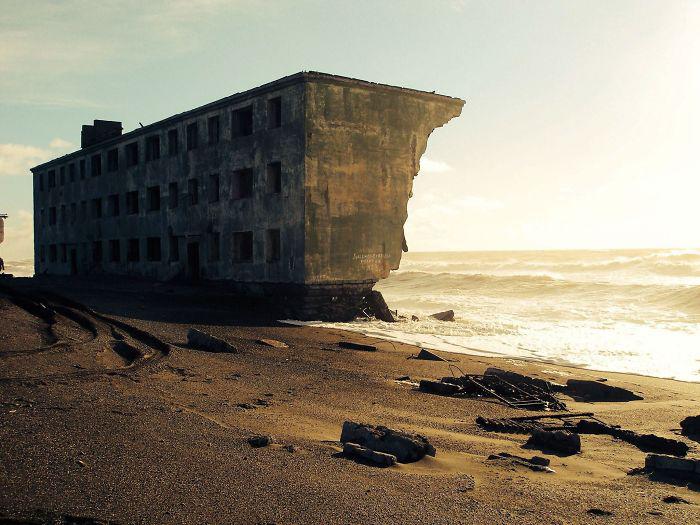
[304,80,464,284]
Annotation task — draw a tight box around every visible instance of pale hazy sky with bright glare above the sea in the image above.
[0,0,700,259]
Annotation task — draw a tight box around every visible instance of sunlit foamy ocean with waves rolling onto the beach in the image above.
[324,249,700,382]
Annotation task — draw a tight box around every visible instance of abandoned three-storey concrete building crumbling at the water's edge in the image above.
[31,72,464,318]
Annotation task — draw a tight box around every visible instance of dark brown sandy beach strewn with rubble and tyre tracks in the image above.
[0,279,700,524]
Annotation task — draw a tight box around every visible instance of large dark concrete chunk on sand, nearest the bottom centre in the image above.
[340,421,435,463]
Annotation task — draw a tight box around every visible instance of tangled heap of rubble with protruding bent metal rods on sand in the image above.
[422,366,566,410]
